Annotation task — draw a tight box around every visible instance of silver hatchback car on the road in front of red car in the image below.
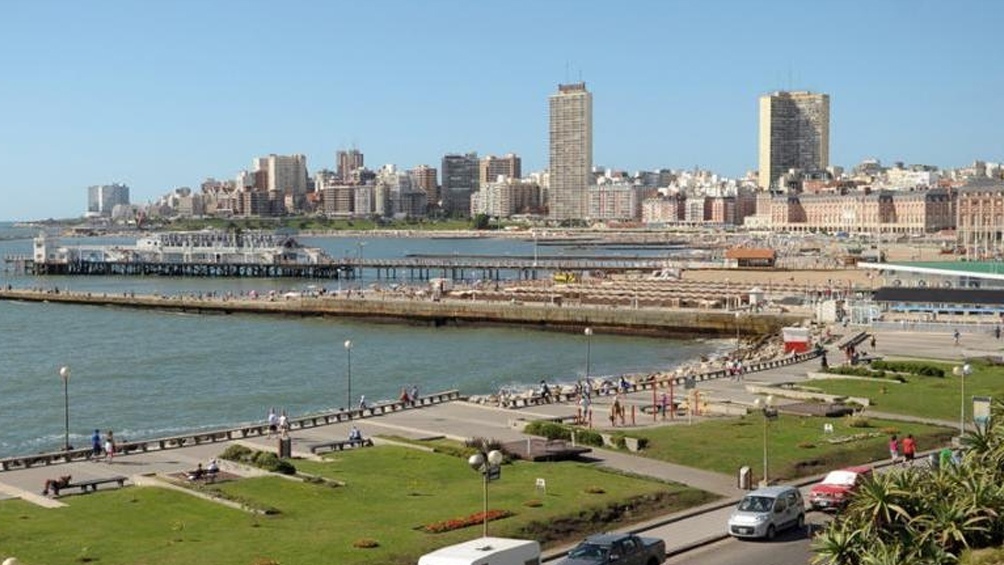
[729,487,805,540]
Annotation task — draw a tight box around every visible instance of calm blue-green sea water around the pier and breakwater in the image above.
[0,223,727,457]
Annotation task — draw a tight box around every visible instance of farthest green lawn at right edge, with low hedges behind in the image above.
[805,361,1004,421]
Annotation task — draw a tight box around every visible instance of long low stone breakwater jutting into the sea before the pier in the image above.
[0,289,804,338]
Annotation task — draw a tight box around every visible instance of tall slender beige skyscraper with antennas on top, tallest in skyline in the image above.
[548,82,592,220]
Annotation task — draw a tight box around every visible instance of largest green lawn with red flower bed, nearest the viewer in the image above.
[0,446,715,565]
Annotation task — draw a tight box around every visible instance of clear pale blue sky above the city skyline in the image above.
[0,0,1004,220]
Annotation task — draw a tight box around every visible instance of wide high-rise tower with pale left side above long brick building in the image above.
[757,90,829,189]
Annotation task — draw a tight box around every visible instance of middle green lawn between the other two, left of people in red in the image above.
[631,413,956,482]
